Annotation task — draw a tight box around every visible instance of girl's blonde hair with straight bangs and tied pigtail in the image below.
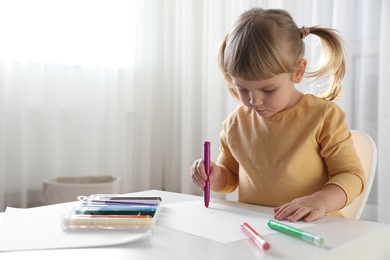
[218,8,345,100]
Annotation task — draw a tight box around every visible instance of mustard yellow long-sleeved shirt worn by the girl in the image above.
[217,94,365,207]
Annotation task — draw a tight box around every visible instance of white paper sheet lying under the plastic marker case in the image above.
[0,203,151,251]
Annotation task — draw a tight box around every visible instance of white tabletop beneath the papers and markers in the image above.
[0,190,390,260]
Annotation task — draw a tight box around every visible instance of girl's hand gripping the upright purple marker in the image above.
[191,159,227,191]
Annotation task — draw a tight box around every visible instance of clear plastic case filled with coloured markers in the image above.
[61,194,162,231]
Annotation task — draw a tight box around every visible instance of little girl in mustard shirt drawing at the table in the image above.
[191,8,365,222]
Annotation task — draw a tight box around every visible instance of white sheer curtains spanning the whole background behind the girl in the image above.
[0,0,390,223]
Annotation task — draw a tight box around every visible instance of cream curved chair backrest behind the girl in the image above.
[341,130,377,219]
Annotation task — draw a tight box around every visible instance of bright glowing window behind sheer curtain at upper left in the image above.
[0,0,135,67]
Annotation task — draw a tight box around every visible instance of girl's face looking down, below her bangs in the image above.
[233,73,303,117]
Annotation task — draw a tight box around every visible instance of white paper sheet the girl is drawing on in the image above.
[157,201,314,243]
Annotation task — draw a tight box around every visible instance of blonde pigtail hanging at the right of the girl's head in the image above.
[307,26,345,101]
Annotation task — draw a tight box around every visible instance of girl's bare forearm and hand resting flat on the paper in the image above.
[274,184,347,222]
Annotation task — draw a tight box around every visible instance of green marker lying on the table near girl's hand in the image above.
[268,219,325,247]
